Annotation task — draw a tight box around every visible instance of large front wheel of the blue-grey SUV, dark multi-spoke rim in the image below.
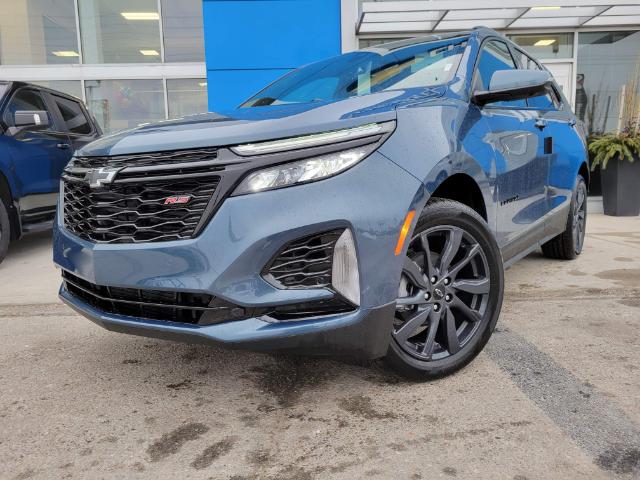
[385,198,504,380]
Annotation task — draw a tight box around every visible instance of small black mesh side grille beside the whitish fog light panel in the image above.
[263,229,344,288]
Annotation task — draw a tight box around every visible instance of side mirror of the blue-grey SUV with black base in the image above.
[472,70,553,106]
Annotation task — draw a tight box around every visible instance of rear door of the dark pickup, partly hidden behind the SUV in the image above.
[48,92,100,154]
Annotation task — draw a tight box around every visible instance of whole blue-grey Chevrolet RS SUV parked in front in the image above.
[54,29,588,378]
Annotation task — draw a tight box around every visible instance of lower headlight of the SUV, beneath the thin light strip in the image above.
[234,146,371,195]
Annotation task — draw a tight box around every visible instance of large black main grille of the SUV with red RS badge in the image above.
[62,149,224,243]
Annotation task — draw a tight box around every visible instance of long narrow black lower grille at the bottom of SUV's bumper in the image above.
[62,271,248,325]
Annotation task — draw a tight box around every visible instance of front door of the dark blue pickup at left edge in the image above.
[2,87,70,214]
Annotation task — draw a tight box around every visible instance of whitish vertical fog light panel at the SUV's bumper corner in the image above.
[331,229,360,305]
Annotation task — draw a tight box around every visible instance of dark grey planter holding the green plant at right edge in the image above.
[601,158,640,217]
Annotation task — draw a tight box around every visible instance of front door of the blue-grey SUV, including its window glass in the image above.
[473,39,549,261]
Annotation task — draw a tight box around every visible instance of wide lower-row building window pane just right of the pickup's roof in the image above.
[85,80,165,132]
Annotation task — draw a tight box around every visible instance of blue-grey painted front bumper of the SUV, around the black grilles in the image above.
[54,152,421,358]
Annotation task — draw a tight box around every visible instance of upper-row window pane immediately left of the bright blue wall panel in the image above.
[162,0,204,62]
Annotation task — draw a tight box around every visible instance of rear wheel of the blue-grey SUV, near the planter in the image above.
[542,175,587,260]
